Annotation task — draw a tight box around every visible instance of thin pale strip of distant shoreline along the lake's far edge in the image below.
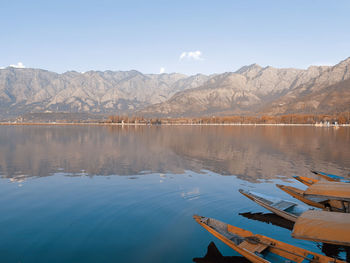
[0,122,350,128]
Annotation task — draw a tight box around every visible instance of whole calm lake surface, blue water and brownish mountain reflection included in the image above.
[0,126,350,262]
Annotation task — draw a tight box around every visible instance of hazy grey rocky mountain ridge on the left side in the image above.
[0,67,208,117]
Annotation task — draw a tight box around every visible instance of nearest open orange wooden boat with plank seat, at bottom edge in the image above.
[193,215,344,263]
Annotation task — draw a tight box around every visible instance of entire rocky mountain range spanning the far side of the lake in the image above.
[0,58,350,118]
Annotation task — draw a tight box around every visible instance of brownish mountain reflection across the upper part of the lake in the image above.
[0,126,350,182]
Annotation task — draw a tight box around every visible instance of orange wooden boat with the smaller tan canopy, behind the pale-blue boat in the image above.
[276,181,350,213]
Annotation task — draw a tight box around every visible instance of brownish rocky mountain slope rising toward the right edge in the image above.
[142,58,350,116]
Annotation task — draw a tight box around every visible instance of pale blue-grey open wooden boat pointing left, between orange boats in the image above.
[239,189,309,222]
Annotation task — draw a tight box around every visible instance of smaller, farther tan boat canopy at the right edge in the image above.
[304,182,350,201]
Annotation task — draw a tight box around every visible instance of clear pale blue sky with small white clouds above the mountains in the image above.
[0,0,350,74]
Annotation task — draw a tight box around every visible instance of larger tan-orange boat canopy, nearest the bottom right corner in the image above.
[292,210,350,246]
